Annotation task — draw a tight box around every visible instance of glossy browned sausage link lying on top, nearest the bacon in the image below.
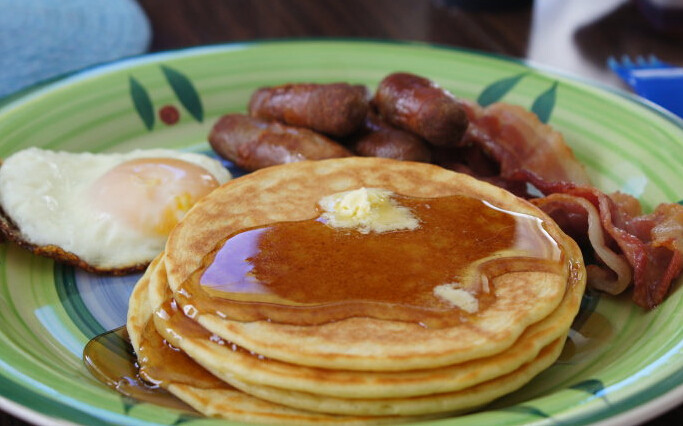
[374,73,468,146]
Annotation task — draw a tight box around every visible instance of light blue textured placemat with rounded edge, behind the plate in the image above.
[0,0,152,98]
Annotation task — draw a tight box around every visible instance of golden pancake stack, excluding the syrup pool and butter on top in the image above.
[128,158,585,424]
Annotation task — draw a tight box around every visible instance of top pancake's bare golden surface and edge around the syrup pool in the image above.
[166,157,585,370]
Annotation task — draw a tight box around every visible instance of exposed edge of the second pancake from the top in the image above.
[148,255,581,399]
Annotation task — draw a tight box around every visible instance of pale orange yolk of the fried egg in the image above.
[90,158,218,235]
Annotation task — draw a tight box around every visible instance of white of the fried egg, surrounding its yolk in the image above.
[0,148,231,270]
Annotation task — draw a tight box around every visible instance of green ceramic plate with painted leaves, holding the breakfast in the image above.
[0,41,683,426]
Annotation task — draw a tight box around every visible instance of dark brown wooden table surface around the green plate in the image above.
[0,0,683,426]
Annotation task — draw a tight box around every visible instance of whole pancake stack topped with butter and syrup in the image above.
[128,157,585,423]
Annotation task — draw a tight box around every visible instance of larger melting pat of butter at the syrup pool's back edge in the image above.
[318,188,420,234]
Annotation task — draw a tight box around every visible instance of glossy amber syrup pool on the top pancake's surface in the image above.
[175,191,566,327]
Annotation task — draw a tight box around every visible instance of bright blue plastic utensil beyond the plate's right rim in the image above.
[607,56,683,117]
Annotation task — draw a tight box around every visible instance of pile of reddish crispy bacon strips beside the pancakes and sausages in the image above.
[440,103,683,309]
